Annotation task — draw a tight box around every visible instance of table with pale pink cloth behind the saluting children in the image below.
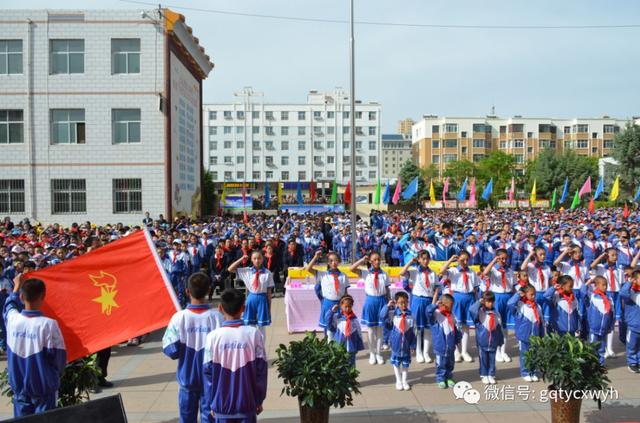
[284,278,403,333]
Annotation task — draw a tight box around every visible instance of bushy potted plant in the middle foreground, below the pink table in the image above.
[274,333,360,423]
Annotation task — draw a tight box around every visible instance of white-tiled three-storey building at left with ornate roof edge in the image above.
[0,9,213,224]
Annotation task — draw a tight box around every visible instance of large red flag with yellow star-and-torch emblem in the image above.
[24,230,179,362]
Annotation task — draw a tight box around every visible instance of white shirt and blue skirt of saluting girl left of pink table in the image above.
[237,267,275,326]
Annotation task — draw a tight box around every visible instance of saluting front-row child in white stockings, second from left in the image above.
[380,291,416,391]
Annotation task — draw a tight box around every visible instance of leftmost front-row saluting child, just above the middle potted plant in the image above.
[324,294,364,367]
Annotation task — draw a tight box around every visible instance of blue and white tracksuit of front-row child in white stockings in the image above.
[380,306,416,369]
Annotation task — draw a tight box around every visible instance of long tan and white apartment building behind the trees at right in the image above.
[412,115,628,175]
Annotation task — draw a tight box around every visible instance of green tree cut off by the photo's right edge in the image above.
[613,122,640,198]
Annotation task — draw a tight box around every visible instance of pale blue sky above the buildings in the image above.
[3,0,640,132]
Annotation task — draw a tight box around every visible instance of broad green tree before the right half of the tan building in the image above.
[526,149,598,198]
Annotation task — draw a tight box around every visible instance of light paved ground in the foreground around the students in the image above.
[0,298,640,423]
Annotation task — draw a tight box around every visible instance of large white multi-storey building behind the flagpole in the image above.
[203,88,381,184]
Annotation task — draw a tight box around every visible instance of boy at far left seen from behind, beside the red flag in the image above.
[3,275,67,417]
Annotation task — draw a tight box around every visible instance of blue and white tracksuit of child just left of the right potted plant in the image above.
[508,292,544,377]
